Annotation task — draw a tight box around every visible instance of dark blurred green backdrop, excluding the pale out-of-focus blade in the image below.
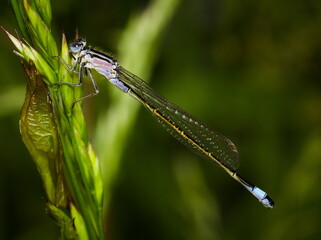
[0,0,321,240]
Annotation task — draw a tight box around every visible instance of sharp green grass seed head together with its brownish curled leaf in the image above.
[6,0,104,240]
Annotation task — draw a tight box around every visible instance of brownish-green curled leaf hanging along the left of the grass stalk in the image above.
[20,61,68,207]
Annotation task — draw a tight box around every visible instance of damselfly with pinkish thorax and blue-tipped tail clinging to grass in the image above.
[58,39,274,208]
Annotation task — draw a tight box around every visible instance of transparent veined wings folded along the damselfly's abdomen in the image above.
[116,66,239,170]
